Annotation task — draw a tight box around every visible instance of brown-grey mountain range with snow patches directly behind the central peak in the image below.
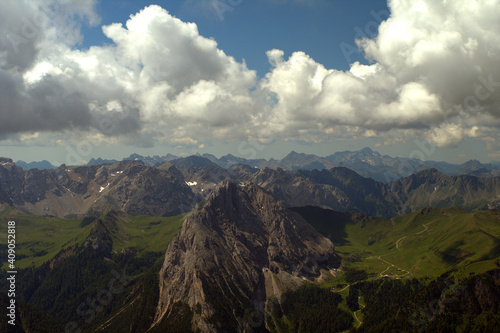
[0,157,500,218]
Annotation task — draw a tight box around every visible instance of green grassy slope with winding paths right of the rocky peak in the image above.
[292,208,500,284]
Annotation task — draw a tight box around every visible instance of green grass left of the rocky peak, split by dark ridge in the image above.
[0,208,185,269]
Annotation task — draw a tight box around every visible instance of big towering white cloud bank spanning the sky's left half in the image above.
[0,1,256,142]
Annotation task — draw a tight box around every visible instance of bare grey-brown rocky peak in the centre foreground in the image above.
[155,181,340,332]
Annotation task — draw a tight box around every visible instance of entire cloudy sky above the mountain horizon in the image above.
[0,0,500,165]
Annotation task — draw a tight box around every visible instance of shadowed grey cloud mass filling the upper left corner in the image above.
[0,0,101,137]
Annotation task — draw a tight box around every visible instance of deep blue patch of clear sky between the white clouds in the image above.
[81,0,389,76]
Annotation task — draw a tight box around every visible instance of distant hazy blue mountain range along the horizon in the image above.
[16,148,500,183]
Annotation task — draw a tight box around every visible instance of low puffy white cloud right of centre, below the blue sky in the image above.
[262,50,441,135]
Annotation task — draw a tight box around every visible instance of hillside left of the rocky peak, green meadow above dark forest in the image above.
[0,209,188,332]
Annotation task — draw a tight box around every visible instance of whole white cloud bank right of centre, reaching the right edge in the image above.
[262,0,500,146]
